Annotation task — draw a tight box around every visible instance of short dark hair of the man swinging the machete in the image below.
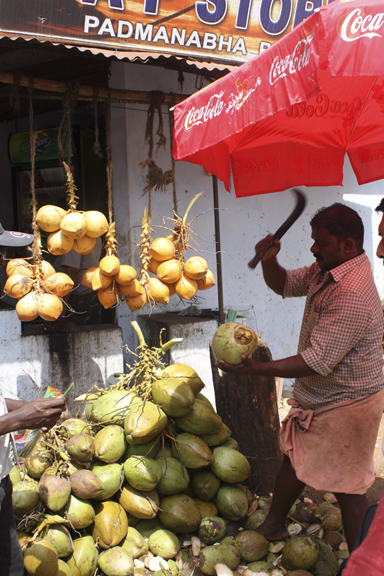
[311,202,364,250]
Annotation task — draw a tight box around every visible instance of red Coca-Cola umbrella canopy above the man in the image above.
[173,0,384,196]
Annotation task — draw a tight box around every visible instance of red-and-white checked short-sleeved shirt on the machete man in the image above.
[283,253,384,410]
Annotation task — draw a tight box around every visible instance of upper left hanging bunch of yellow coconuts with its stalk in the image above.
[36,161,108,256]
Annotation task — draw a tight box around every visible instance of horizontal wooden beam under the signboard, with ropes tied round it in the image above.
[0,72,189,106]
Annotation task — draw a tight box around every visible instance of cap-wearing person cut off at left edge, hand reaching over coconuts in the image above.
[0,224,66,576]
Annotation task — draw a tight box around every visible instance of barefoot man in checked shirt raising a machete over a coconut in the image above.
[217,204,384,550]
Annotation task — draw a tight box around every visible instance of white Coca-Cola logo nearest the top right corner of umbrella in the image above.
[337,8,384,42]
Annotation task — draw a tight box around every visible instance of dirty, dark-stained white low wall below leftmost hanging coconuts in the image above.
[0,310,124,415]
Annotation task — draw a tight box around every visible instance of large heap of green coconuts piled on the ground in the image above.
[11,364,347,576]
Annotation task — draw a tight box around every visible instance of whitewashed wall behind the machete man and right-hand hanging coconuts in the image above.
[110,62,384,396]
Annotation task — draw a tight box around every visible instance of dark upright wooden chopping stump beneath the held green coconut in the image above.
[211,342,282,495]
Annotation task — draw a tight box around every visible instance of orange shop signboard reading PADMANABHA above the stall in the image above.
[0,0,332,64]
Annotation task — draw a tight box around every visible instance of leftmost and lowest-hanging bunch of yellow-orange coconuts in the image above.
[3,258,73,322]
